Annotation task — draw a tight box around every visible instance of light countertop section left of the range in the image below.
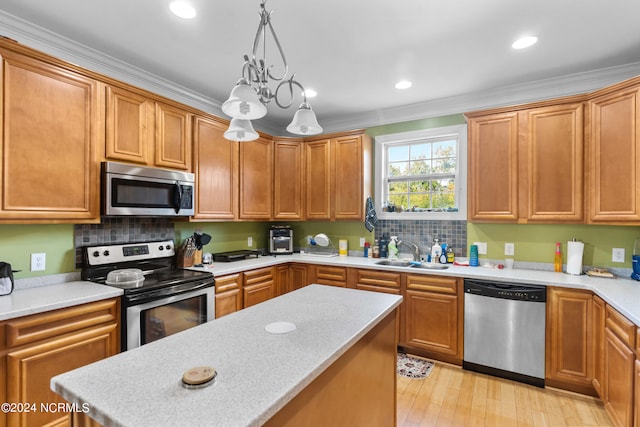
[0,280,123,321]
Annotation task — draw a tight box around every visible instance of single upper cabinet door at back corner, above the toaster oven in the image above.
[273,140,304,220]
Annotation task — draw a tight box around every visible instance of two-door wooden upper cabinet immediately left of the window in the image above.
[305,131,371,220]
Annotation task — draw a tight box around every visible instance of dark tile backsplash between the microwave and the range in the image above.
[73,217,175,268]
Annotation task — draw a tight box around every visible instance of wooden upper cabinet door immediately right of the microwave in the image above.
[194,117,239,220]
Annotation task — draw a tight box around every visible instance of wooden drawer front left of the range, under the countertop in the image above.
[2,298,120,348]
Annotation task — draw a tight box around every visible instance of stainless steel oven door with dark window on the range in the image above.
[123,286,215,350]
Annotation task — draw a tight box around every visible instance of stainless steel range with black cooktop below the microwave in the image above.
[82,240,215,351]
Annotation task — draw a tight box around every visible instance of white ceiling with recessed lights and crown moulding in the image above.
[0,0,640,134]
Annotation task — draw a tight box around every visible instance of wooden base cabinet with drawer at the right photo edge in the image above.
[602,305,636,426]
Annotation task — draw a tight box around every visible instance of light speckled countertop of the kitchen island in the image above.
[51,285,402,427]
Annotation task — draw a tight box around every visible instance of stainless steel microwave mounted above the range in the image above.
[102,162,195,216]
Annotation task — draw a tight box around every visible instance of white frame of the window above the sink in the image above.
[374,124,467,220]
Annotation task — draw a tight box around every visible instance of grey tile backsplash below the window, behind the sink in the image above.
[375,220,467,257]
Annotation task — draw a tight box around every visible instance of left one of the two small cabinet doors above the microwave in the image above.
[105,86,155,165]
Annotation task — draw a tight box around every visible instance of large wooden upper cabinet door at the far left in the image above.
[0,49,104,223]
